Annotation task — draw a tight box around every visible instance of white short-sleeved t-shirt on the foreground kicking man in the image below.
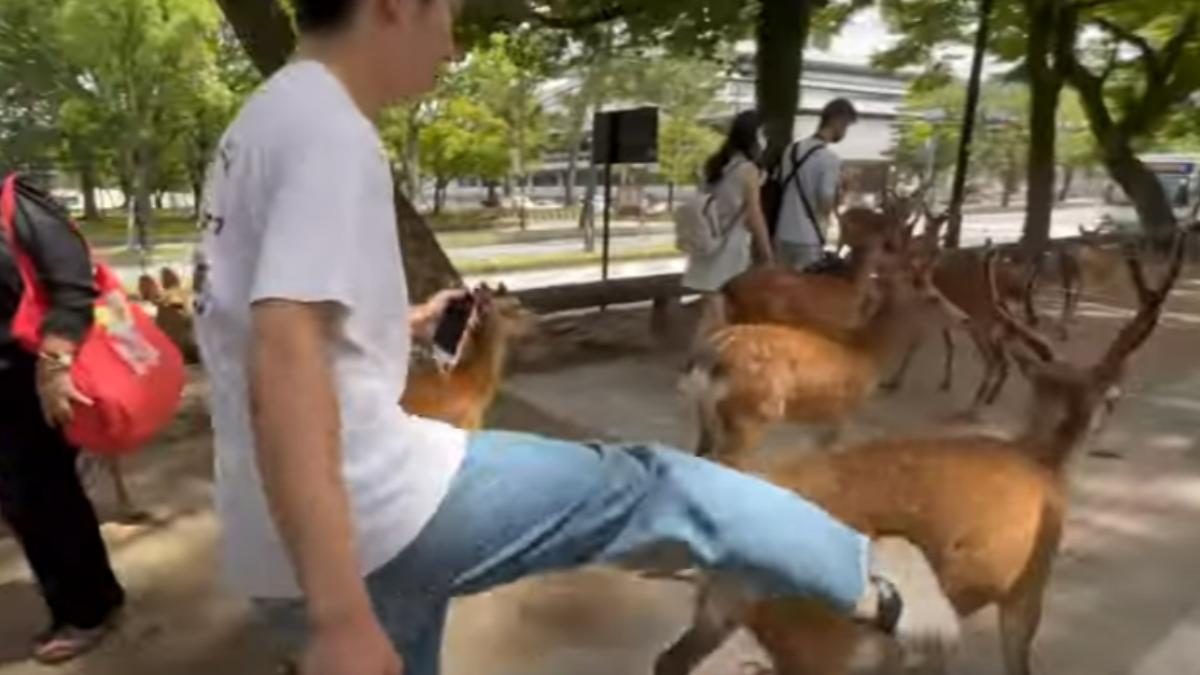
[197,61,467,598]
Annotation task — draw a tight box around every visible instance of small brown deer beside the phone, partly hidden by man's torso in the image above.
[401,286,536,431]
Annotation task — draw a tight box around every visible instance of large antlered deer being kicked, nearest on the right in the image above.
[655,229,1186,675]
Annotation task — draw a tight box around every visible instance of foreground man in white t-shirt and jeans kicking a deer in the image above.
[197,0,958,675]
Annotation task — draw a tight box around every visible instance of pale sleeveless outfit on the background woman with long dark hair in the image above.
[683,155,758,293]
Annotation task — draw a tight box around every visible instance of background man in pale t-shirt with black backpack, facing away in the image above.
[775,98,858,270]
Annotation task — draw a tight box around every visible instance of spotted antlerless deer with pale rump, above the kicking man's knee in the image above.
[680,253,966,459]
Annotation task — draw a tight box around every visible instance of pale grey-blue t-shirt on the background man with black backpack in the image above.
[775,138,841,246]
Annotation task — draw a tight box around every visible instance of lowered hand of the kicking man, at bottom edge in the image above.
[300,617,404,675]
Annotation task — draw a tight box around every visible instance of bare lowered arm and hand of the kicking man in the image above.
[250,300,400,675]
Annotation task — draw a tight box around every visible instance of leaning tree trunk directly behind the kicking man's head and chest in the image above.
[217,0,462,299]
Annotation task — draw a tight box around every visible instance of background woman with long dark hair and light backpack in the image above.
[683,110,774,294]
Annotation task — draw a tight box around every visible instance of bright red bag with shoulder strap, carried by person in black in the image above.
[0,175,186,455]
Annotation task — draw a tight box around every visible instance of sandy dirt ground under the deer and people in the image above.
[0,260,1200,675]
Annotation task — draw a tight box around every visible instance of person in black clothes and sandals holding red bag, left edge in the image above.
[0,178,125,663]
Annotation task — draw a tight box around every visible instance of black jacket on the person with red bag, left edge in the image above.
[0,179,96,351]
